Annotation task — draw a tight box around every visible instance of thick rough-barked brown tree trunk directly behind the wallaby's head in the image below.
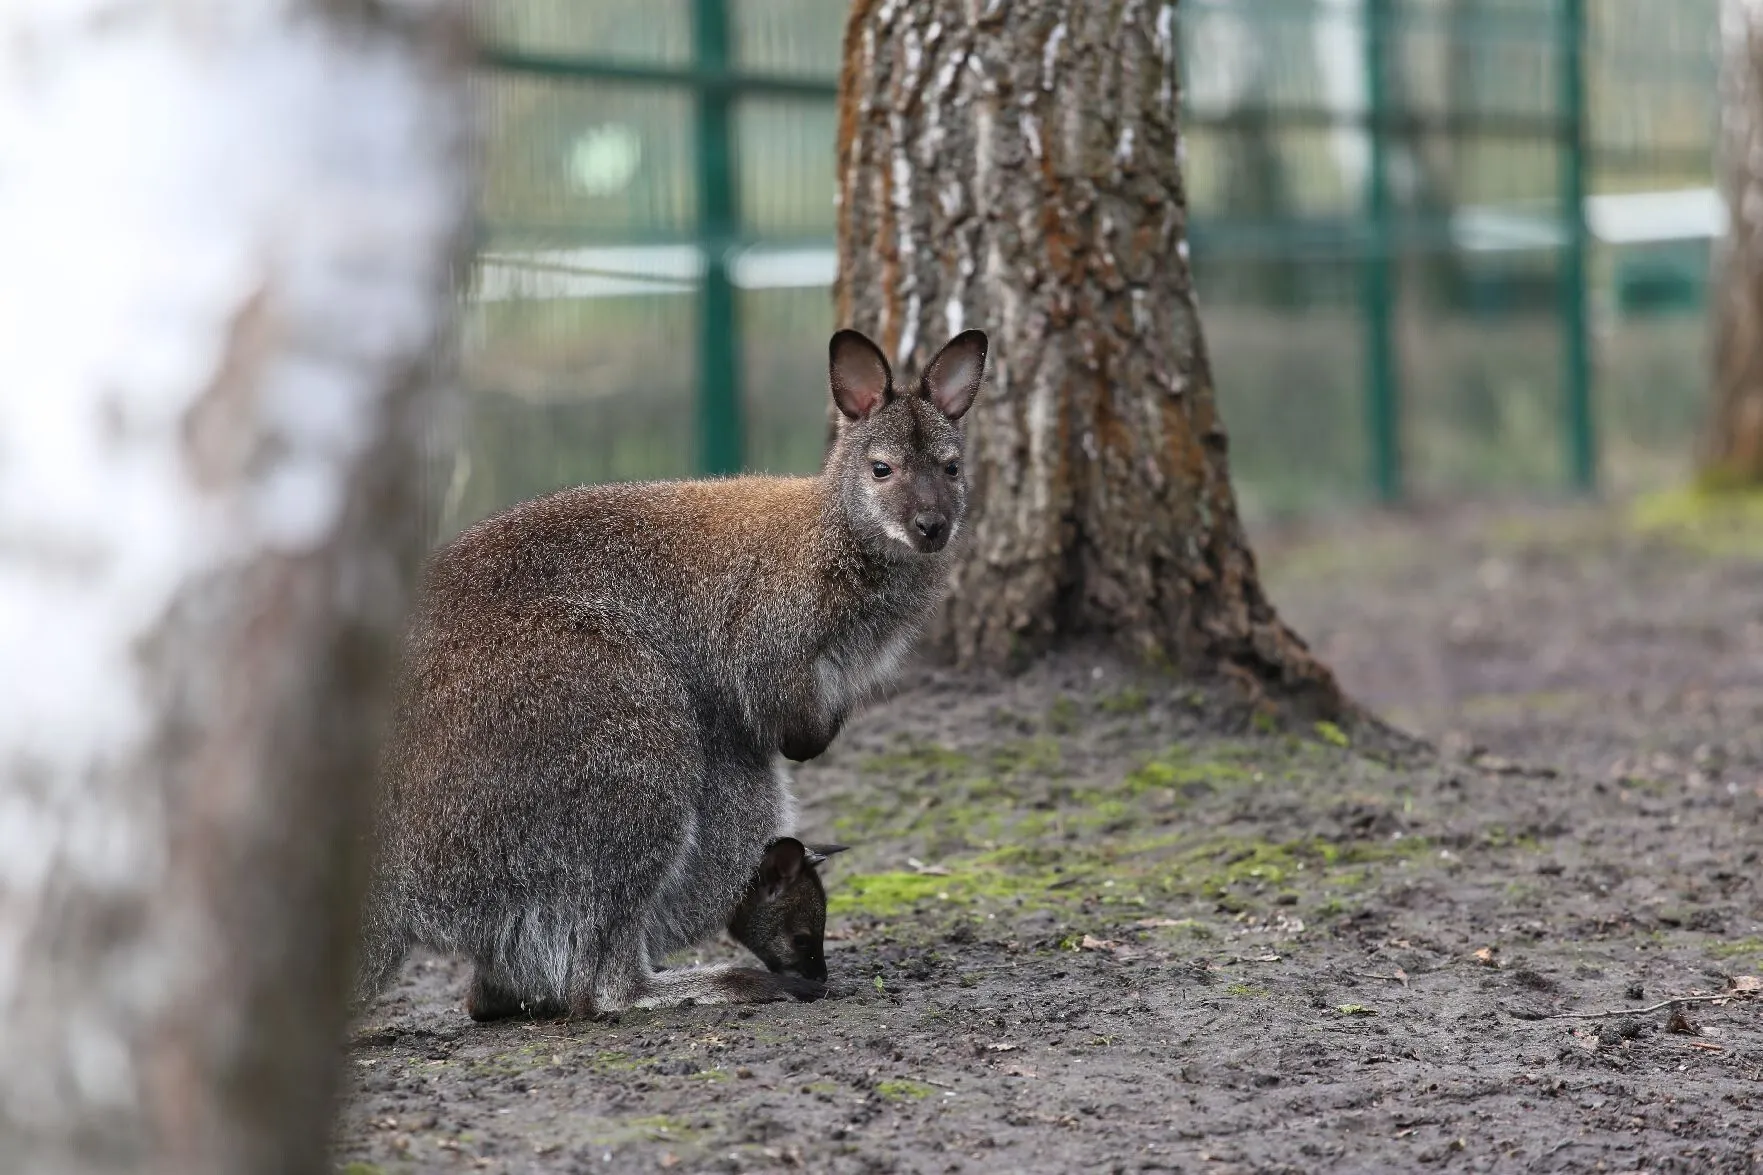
[837,0,1343,715]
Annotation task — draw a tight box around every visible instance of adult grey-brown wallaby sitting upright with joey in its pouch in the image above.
[356,330,986,1016]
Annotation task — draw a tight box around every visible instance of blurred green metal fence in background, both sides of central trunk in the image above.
[448,0,1719,526]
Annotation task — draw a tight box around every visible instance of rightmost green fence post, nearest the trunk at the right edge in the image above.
[1555,0,1597,492]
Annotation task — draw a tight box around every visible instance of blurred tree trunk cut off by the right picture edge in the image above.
[1707,0,1763,485]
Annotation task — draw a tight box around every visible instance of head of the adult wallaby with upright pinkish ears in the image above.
[827,330,986,558]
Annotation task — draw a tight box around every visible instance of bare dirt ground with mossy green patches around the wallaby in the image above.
[337,508,1763,1175]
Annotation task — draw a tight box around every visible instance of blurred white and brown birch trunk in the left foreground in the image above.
[0,0,469,1175]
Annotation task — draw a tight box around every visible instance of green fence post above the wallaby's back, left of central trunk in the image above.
[693,0,744,475]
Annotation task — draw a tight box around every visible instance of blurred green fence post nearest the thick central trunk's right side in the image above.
[1359,0,1402,501]
